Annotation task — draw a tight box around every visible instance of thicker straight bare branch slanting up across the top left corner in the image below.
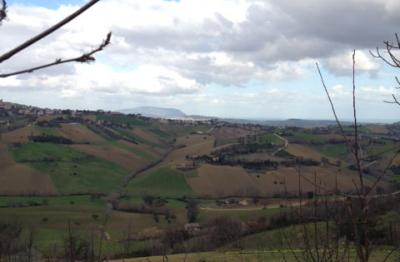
[0,0,100,63]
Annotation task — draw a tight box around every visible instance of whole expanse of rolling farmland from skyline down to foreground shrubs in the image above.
[0,106,400,261]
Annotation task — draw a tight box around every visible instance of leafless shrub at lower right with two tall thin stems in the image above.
[281,49,400,262]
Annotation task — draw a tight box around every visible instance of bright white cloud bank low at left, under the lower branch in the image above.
[0,63,203,97]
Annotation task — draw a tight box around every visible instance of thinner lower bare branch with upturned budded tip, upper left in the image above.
[0,32,112,78]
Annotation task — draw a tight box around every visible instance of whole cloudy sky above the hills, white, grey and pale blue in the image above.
[0,0,400,121]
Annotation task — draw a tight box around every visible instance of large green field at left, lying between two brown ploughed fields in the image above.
[11,143,128,193]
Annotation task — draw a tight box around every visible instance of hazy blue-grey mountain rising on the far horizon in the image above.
[119,106,186,119]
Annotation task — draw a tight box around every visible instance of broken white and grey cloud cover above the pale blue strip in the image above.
[0,0,400,118]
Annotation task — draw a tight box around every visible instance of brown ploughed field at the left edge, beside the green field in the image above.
[0,144,57,195]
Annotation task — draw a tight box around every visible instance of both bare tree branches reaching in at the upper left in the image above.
[0,0,111,78]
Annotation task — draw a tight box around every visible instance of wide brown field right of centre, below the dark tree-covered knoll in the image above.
[187,164,370,197]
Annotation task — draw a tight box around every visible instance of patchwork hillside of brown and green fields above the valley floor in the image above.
[0,101,398,197]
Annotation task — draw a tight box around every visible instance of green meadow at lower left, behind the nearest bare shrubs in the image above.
[0,203,169,254]
